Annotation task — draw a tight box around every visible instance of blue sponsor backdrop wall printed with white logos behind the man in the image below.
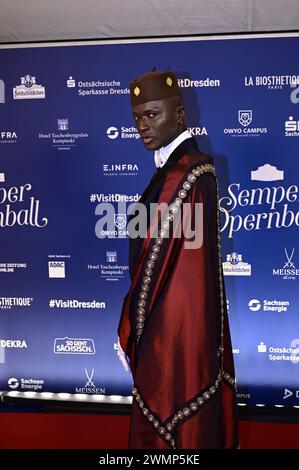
[0,35,299,405]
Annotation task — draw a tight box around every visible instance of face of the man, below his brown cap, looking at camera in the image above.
[132,97,184,150]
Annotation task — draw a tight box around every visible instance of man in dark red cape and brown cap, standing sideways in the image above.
[118,71,238,449]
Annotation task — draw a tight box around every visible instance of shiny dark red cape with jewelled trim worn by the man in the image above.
[118,140,238,449]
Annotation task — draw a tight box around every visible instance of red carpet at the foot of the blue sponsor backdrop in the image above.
[0,413,299,449]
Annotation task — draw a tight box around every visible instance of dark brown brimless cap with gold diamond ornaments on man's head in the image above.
[130,70,181,106]
